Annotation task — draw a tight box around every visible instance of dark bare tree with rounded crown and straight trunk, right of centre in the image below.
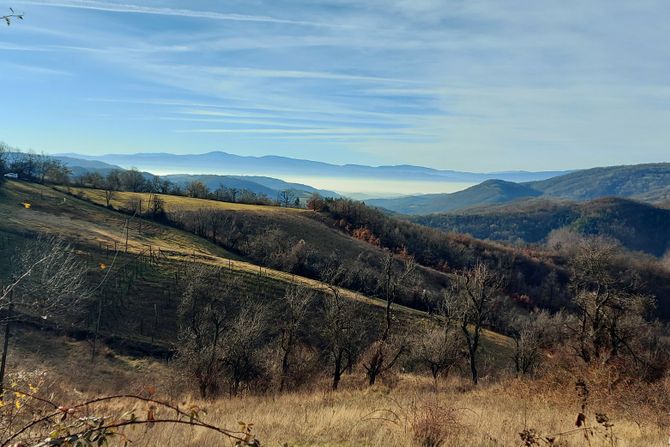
[441,262,505,384]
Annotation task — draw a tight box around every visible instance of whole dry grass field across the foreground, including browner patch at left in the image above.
[5,331,668,447]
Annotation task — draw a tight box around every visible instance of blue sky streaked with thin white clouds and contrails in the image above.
[0,0,670,172]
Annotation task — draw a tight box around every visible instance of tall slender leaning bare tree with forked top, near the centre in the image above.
[363,253,416,385]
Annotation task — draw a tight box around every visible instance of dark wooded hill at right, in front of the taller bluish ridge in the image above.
[410,198,670,256]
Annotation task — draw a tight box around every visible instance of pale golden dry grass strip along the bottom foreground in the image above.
[109,376,667,447]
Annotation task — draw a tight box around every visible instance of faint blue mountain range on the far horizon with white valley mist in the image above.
[61,151,568,186]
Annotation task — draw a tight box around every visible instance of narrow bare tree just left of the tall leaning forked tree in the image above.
[279,285,314,391]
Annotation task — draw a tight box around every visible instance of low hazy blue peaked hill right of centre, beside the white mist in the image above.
[366,180,541,214]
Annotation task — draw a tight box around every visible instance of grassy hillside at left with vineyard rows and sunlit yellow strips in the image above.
[0,180,509,356]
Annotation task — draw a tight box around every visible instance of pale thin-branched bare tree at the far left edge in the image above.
[0,237,90,390]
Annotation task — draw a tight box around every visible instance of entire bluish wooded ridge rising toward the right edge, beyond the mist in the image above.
[366,163,670,214]
